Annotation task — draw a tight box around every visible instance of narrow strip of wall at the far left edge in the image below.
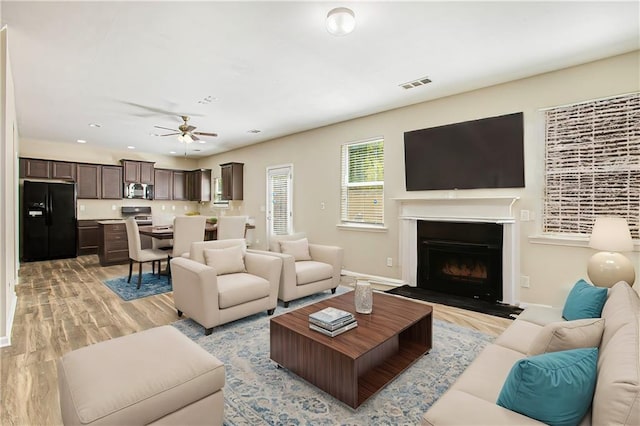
[0,28,18,346]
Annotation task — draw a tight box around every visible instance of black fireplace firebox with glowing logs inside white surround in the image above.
[417,220,503,302]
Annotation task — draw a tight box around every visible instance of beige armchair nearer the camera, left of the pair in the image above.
[171,239,282,335]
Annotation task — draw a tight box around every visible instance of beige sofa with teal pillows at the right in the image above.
[422,282,640,426]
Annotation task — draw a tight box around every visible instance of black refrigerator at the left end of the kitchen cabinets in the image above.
[22,181,77,262]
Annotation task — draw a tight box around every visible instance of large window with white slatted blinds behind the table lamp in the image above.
[543,93,640,238]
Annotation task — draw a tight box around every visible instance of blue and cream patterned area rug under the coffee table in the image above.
[172,287,493,426]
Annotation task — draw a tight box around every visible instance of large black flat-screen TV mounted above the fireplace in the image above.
[404,112,524,191]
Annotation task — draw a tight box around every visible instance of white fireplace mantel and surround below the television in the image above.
[393,196,520,305]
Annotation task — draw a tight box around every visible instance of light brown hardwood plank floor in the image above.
[0,256,510,426]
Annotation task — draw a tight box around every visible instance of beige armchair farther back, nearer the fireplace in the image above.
[248,232,343,308]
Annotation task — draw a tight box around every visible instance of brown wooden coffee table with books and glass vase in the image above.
[270,291,432,408]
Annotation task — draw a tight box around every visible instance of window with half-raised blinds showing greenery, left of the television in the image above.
[340,139,384,225]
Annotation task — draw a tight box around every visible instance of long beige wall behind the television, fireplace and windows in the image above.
[199,51,640,306]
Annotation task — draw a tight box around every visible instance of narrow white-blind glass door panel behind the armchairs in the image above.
[268,167,293,235]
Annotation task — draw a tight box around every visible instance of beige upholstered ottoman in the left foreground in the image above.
[58,325,224,425]
